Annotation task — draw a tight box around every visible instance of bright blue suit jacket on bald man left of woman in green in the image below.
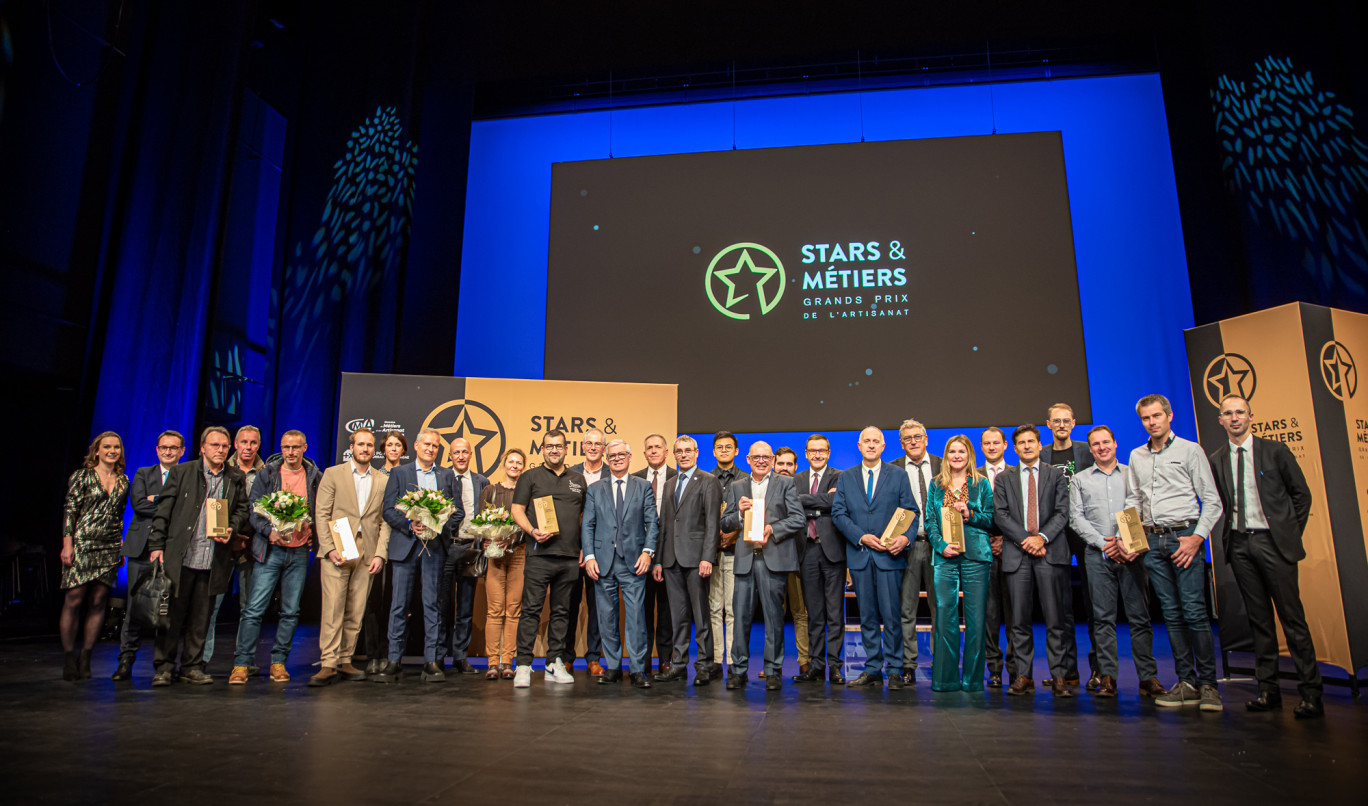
[832,463,921,571]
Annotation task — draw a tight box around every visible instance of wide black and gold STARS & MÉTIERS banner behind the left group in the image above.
[337,372,679,657]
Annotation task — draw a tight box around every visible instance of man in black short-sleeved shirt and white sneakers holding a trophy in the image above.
[513,428,586,688]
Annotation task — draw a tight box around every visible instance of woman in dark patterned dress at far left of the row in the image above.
[59,431,129,680]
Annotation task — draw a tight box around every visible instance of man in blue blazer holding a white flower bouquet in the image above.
[372,428,465,683]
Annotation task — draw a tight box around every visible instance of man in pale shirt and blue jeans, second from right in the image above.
[1126,394,1222,712]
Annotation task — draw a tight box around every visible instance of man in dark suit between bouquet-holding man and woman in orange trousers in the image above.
[438,437,490,675]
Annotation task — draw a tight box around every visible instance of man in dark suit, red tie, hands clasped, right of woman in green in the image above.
[993,426,1074,697]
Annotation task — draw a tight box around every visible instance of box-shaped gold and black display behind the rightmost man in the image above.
[1185,302,1368,688]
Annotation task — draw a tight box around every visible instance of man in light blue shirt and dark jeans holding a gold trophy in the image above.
[1068,426,1164,697]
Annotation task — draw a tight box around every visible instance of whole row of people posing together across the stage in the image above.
[62,394,1323,717]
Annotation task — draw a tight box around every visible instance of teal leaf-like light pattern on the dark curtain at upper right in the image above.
[1211,56,1368,296]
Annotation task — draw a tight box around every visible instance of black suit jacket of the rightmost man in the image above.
[1209,437,1311,562]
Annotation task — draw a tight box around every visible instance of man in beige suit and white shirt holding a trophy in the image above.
[309,428,390,687]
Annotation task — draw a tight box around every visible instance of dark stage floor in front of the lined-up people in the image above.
[0,625,1368,805]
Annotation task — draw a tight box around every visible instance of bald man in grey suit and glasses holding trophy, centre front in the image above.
[720,442,807,691]
